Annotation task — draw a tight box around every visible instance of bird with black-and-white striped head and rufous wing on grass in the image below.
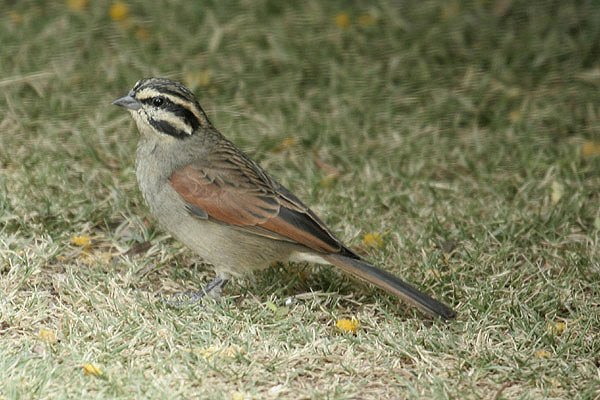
[113,77,456,320]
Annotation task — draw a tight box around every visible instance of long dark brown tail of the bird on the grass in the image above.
[322,254,456,319]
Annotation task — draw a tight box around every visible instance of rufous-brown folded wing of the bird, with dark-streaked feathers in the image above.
[170,146,351,254]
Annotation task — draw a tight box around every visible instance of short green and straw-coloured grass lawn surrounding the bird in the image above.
[0,0,600,399]
